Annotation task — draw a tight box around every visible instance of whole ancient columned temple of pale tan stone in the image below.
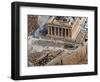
[48,17,81,40]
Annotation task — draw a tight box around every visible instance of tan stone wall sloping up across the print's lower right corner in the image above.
[47,45,88,65]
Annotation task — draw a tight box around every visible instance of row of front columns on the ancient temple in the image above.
[48,26,71,37]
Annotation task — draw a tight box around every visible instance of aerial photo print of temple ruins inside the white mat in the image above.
[27,15,88,67]
